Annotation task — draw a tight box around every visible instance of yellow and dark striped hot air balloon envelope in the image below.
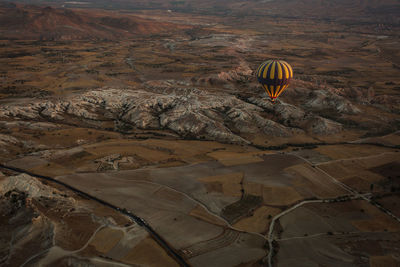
[256,60,293,102]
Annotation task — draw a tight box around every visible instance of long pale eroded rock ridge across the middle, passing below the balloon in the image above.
[0,86,345,143]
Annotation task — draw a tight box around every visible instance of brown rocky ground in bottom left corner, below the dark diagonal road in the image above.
[0,174,179,266]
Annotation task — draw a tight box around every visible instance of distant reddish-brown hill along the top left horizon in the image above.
[0,3,186,40]
